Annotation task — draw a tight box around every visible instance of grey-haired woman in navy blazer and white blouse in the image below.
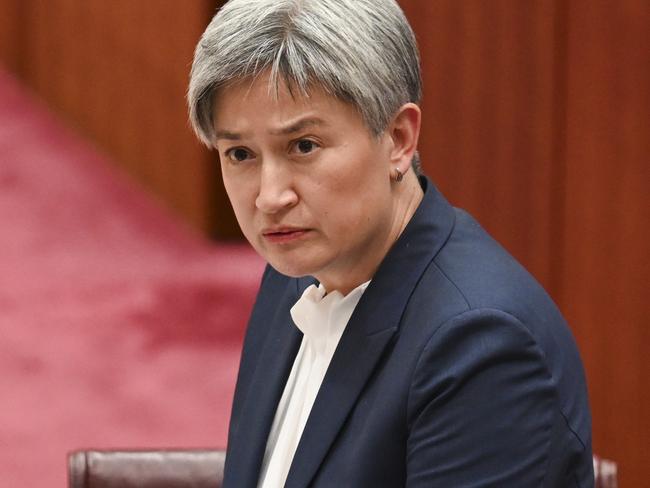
[188,0,593,488]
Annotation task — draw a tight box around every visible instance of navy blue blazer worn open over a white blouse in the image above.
[224,178,593,488]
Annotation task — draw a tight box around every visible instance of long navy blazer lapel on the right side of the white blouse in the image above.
[285,180,454,488]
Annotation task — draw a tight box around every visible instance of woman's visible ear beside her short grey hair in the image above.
[388,103,422,174]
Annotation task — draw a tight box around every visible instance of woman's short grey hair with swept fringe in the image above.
[187,0,422,169]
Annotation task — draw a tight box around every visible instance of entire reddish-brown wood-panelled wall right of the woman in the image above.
[400,0,650,486]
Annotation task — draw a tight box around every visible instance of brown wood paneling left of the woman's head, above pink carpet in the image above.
[0,0,238,237]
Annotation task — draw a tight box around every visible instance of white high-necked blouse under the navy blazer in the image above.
[257,281,370,488]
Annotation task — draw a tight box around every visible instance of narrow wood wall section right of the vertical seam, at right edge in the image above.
[560,0,650,487]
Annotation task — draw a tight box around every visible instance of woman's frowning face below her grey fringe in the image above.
[214,77,395,292]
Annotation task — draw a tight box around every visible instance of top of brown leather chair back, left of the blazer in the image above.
[68,449,226,488]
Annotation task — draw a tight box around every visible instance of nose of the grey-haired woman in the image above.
[255,162,298,214]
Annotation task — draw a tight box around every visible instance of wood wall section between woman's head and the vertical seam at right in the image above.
[401,0,562,287]
